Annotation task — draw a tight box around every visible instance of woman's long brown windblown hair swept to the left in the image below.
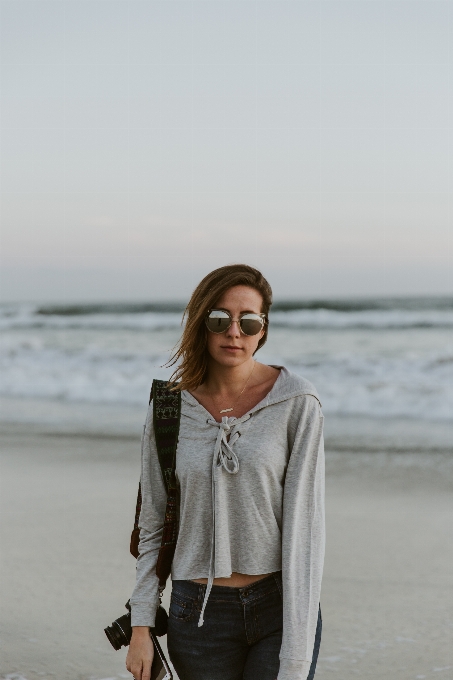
[167,264,272,390]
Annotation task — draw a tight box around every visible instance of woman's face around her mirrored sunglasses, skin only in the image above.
[207,286,264,366]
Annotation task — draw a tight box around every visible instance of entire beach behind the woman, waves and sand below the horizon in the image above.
[0,298,453,680]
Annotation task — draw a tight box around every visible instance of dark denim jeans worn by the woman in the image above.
[168,572,322,680]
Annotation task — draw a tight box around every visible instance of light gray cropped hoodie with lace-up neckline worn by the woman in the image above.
[131,366,325,680]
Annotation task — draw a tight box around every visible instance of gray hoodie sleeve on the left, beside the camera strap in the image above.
[130,404,167,626]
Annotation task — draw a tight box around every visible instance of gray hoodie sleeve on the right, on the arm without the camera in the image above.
[278,395,325,680]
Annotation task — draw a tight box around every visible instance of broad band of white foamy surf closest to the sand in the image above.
[0,341,453,420]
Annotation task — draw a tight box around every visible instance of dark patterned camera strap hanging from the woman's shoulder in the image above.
[130,380,181,588]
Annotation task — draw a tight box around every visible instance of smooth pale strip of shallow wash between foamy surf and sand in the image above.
[0,397,453,454]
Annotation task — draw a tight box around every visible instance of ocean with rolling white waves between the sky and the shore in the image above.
[0,297,453,421]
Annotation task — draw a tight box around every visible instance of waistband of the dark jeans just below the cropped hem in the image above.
[173,571,282,603]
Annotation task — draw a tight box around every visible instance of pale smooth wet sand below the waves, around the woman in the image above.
[0,414,453,680]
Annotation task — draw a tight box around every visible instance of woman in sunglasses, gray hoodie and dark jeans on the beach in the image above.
[126,265,325,680]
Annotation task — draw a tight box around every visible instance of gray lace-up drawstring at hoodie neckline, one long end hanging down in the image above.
[198,414,250,627]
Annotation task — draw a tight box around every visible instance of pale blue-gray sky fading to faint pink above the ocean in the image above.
[0,0,453,302]
